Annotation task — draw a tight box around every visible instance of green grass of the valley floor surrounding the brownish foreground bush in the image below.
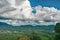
[0,30,54,40]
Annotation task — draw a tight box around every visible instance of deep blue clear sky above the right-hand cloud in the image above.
[30,0,60,10]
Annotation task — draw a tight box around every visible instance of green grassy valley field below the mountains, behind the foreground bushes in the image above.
[0,30,54,40]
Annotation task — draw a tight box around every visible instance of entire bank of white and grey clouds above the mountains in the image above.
[0,0,60,26]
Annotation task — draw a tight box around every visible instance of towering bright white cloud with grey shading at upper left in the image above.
[0,0,32,19]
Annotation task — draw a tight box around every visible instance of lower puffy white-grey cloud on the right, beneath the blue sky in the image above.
[35,6,60,21]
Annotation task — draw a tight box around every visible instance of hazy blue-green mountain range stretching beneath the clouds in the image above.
[0,22,55,31]
